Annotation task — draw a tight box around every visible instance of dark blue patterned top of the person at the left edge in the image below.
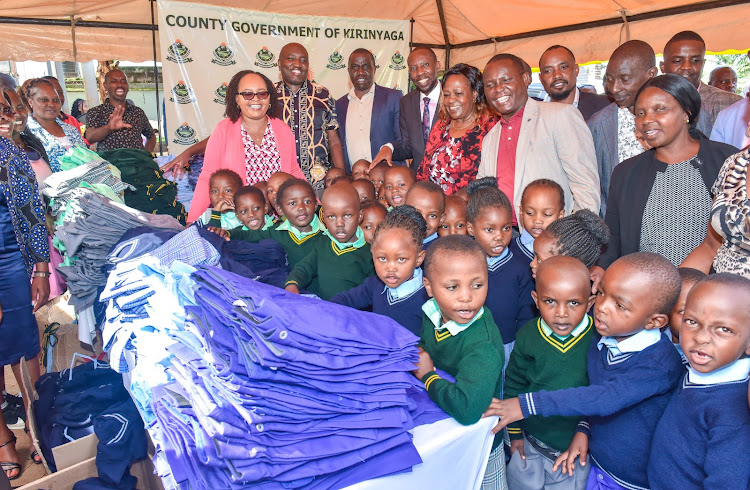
[0,137,49,277]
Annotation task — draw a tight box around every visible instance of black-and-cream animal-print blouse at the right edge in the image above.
[711,149,750,279]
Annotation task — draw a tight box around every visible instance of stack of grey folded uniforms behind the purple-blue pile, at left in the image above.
[54,188,182,344]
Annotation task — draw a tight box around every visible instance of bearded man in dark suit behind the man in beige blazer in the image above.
[539,45,609,121]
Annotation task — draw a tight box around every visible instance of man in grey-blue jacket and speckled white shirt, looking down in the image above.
[588,40,658,218]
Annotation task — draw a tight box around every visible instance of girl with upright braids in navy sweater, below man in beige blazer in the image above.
[466,177,536,369]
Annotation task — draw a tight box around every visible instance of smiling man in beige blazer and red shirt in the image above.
[477,54,600,224]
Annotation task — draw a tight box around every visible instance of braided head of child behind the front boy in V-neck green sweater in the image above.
[530,209,609,278]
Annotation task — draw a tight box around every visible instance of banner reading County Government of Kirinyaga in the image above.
[158,0,409,155]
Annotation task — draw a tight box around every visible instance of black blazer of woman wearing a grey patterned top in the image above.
[599,136,739,269]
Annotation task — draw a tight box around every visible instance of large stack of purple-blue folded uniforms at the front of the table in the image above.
[101,256,428,490]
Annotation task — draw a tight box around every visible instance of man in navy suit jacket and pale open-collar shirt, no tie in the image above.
[336,48,403,172]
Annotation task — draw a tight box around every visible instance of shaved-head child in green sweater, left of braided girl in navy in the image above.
[284,182,375,300]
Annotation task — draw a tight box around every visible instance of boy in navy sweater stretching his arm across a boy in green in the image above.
[485,253,688,489]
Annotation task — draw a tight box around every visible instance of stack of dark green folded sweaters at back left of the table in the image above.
[100,148,187,225]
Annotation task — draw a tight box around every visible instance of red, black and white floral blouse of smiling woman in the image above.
[417,117,498,195]
